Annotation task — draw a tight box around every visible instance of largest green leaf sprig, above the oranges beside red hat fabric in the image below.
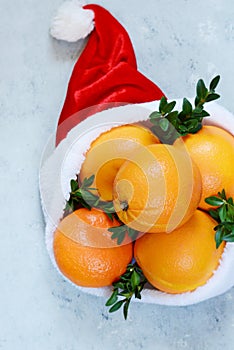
[149,75,220,144]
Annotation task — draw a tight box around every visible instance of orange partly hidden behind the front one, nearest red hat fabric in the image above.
[80,124,159,201]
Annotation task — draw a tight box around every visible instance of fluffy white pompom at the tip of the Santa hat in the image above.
[50,0,94,42]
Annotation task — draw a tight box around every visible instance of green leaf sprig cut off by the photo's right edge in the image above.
[205,189,234,248]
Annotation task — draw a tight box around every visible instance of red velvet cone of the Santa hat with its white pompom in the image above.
[51,0,163,144]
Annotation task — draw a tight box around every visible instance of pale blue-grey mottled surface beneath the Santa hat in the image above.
[0,0,234,350]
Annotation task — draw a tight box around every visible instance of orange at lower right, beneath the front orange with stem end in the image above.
[134,210,224,293]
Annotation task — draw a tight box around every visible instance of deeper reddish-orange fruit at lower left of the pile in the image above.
[53,208,132,287]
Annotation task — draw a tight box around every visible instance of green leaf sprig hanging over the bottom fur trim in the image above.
[106,262,147,320]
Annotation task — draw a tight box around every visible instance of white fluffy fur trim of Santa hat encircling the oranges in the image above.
[40,100,234,306]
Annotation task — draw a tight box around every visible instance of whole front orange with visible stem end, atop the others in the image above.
[113,144,201,233]
